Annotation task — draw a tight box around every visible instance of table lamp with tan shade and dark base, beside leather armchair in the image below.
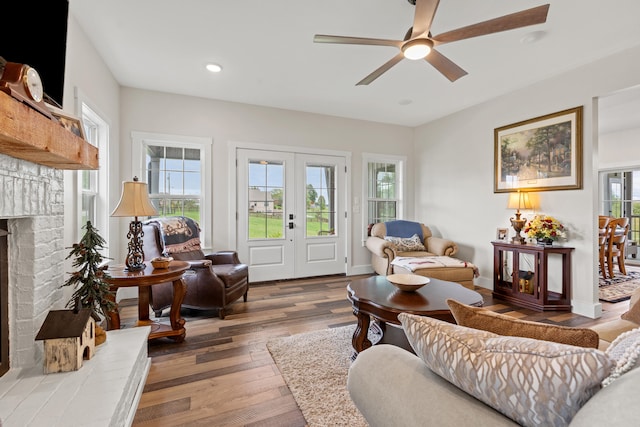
[111,176,158,271]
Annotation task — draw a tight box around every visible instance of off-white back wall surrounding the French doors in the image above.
[119,88,414,274]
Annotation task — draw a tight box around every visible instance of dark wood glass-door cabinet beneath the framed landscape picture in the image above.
[491,241,574,311]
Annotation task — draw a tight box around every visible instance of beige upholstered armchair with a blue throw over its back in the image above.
[366,220,458,276]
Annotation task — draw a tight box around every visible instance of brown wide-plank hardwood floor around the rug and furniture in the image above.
[120,276,629,427]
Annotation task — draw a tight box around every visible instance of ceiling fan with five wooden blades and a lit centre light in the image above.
[313,0,549,86]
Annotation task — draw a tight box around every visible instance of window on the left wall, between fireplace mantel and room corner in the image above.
[78,102,109,241]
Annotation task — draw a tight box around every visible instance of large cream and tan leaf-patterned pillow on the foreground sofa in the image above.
[398,313,615,426]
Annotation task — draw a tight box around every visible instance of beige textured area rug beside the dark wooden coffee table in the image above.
[267,325,368,427]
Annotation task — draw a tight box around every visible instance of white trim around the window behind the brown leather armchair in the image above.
[128,131,213,249]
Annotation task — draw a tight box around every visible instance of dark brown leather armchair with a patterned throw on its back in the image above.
[142,217,249,319]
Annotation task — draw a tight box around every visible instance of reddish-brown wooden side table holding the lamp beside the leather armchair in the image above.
[105,261,189,342]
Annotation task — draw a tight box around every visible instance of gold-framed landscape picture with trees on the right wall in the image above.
[494,106,582,193]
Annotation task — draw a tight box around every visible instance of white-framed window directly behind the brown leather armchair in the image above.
[133,132,211,245]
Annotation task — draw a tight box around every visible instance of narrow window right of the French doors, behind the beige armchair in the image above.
[363,154,405,224]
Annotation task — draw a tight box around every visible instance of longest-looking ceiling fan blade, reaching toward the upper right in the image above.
[432,4,549,46]
